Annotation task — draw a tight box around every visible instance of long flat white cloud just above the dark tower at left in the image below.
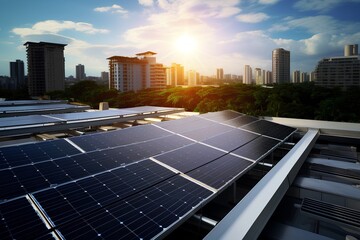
[12,20,109,37]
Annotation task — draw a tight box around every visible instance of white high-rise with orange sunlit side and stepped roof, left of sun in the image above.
[108,51,166,92]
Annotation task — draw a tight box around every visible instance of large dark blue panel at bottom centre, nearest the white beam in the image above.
[58,176,212,239]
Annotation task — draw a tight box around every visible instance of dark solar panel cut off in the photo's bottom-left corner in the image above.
[0,198,53,240]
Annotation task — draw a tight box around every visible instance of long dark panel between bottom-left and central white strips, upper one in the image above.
[34,160,175,225]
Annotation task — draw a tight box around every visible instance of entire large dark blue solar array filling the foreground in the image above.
[0,111,296,239]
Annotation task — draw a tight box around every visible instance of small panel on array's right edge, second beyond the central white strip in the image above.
[233,136,280,161]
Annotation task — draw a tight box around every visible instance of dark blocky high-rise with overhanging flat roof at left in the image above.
[24,42,66,96]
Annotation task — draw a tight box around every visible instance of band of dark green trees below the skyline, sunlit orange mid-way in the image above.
[45,81,360,122]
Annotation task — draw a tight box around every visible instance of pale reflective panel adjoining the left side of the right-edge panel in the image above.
[204,129,259,152]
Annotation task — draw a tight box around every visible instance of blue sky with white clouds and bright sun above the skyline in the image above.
[0,0,360,76]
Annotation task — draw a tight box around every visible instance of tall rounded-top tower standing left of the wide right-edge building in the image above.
[272,48,290,83]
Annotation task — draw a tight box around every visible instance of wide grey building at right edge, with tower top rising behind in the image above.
[315,44,360,89]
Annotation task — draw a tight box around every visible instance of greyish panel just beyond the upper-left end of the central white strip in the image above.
[155,143,225,172]
